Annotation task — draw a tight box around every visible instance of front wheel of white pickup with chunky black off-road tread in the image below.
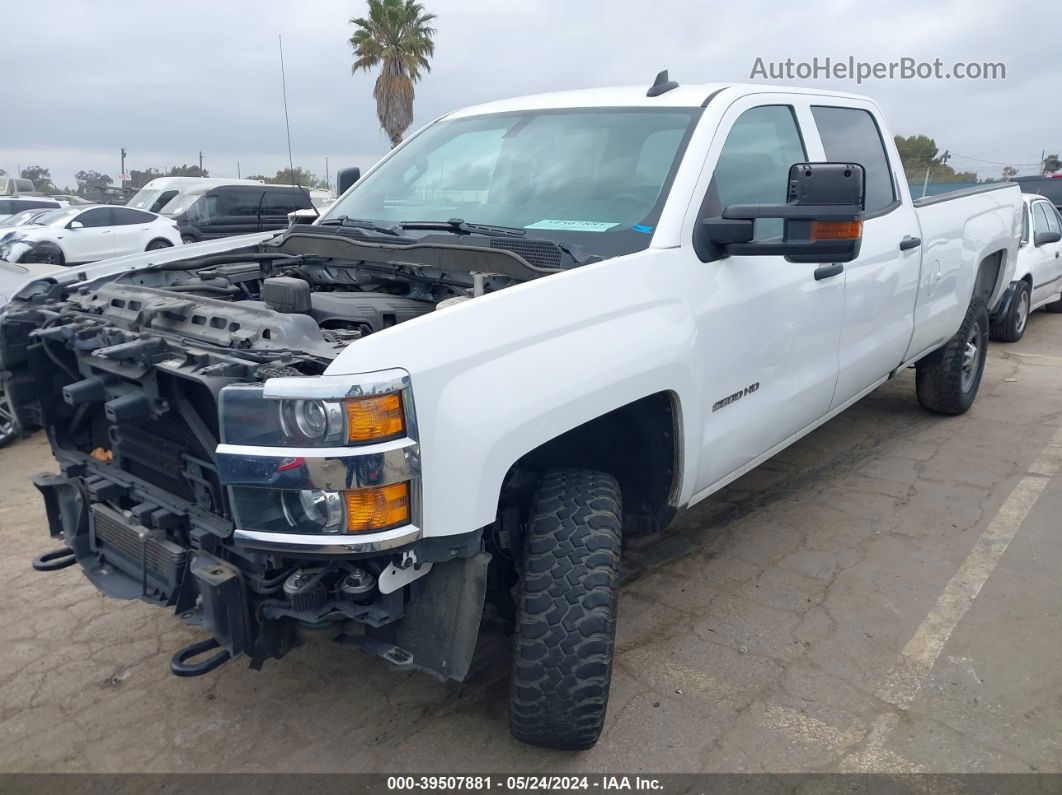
[509,469,622,750]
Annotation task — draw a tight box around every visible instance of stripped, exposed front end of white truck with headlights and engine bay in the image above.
[0,230,564,679]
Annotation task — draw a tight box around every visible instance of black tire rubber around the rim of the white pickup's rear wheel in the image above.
[914,298,989,414]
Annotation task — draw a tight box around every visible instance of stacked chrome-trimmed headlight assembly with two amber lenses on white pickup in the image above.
[217,370,419,545]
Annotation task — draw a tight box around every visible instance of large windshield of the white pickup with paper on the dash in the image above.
[327,108,701,257]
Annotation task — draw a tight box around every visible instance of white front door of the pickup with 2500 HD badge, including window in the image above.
[693,96,844,489]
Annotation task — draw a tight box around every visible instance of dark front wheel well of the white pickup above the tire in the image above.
[502,392,681,534]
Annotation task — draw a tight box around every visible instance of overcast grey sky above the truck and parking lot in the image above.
[0,0,1062,186]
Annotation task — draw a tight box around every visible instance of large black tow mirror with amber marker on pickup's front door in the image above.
[693,162,867,262]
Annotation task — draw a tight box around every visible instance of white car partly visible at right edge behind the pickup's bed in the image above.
[992,193,1062,342]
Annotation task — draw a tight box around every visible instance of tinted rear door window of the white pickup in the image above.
[811,107,896,212]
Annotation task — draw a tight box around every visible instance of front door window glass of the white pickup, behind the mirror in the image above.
[708,105,807,240]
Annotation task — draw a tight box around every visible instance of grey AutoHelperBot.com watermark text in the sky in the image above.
[749,55,1007,83]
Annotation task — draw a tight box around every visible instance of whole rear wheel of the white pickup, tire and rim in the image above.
[914,298,989,414]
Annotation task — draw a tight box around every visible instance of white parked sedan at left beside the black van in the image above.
[0,205,181,265]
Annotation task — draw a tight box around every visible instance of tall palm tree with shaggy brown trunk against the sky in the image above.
[350,0,435,148]
